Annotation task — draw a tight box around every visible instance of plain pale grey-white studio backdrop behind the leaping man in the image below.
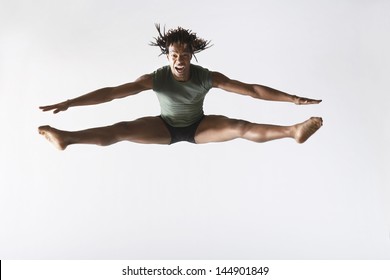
[0,0,390,259]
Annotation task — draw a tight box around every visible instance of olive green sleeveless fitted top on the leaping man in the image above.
[153,64,213,127]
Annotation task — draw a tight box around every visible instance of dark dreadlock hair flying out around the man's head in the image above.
[150,23,211,61]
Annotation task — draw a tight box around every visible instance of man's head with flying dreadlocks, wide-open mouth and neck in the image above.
[151,24,210,81]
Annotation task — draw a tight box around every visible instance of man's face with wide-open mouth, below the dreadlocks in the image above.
[167,43,192,82]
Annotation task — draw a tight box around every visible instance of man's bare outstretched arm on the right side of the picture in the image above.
[212,72,322,105]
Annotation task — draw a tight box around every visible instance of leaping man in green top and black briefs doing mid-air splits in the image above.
[38,25,322,150]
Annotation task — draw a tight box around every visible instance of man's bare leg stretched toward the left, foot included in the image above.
[38,117,171,150]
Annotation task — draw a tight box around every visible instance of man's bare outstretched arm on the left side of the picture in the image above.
[39,74,153,114]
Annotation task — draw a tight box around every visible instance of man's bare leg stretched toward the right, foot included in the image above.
[195,116,322,144]
